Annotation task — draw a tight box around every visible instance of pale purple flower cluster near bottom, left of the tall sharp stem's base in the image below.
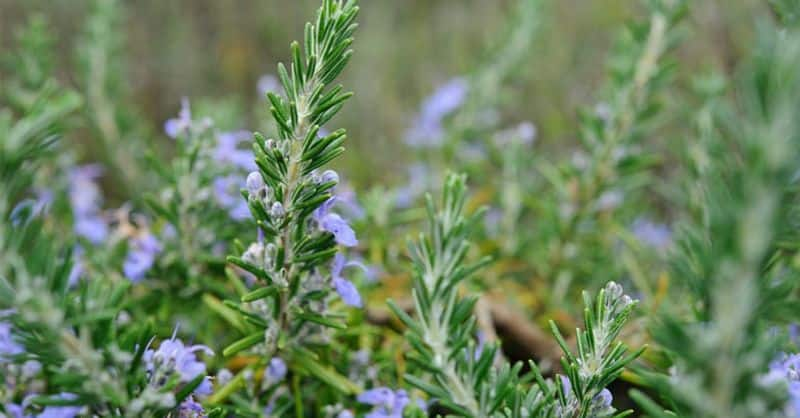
[142,330,214,395]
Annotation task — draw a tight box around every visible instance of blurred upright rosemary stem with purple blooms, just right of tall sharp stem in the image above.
[357,0,546,282]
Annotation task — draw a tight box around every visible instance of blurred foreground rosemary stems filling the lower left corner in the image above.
[0,54,210,417]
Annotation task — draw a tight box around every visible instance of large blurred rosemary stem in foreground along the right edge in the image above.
[634,8,800,417]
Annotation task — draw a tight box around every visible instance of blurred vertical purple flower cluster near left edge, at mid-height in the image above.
[69,164,108,244]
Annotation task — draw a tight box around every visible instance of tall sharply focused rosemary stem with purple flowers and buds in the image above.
[214,0,362,410]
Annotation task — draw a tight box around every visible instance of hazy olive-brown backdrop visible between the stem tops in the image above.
[0,0,768,187]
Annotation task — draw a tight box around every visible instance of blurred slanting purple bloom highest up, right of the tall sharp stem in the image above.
[406,78,469,147]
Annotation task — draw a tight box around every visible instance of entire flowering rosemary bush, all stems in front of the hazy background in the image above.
[7,0,800,418]
